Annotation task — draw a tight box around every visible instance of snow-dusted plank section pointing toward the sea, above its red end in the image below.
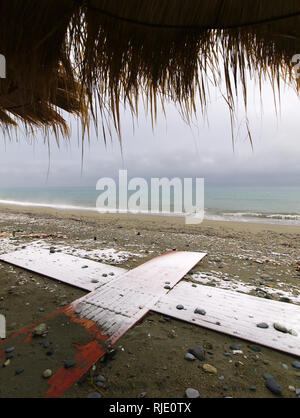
[71,252,206,343]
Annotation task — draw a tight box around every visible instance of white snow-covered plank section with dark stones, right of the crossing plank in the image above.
[152,282,300,356]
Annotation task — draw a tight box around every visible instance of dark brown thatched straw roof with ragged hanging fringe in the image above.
[0,0,300,139]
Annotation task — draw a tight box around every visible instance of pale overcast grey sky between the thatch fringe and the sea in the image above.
[0,79,300,187]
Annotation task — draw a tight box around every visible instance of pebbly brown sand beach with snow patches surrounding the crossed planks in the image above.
[0,206,300,398]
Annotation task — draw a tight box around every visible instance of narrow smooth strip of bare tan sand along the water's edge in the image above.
[0,203,300,234]
